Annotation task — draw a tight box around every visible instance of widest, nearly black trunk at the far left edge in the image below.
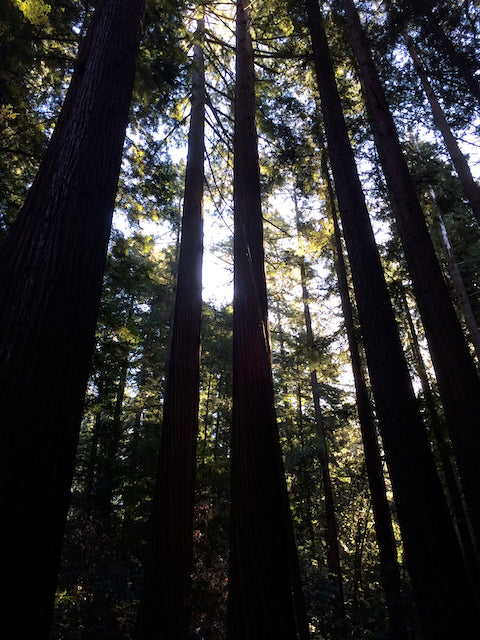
[0,0,144,638]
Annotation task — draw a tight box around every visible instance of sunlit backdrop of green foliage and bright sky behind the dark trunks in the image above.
[0,0,480,639]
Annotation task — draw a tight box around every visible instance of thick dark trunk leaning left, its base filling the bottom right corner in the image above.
[305,0,478,639]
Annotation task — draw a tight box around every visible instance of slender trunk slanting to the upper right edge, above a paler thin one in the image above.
[405,35,480,224]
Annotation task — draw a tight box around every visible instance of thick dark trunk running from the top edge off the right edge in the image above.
[343,0,480,552]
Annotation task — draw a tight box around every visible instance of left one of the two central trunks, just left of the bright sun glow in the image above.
[135,19,205,640]
